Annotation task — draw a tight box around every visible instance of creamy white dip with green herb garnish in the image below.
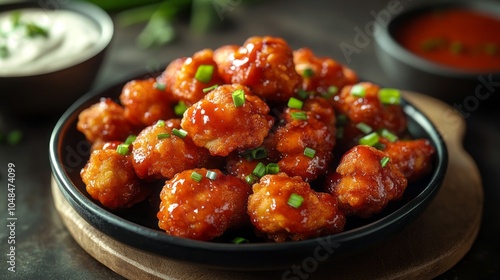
[0,9,100,76]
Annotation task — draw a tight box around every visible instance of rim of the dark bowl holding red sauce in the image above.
[374,0,500,79]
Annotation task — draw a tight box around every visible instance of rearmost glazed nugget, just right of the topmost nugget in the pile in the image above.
[293,48,357,94]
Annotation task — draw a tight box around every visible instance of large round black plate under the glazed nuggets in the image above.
[49,70,448,270]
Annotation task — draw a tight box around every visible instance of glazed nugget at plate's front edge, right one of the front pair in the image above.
[248,173,345,242]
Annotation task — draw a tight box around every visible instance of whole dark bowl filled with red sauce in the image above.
[375,1,500,103]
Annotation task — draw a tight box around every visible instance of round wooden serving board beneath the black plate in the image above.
[52,93,483,280]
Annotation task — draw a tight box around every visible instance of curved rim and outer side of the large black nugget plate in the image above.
[49,71,448,270]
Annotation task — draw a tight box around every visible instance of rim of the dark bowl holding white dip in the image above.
[0,1,114,77]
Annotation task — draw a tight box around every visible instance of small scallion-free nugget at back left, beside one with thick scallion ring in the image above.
[120,78,174,127]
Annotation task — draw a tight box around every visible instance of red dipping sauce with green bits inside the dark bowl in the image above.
[395,8,500,71]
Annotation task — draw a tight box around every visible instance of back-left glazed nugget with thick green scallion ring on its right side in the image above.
[162,49,223,105]
